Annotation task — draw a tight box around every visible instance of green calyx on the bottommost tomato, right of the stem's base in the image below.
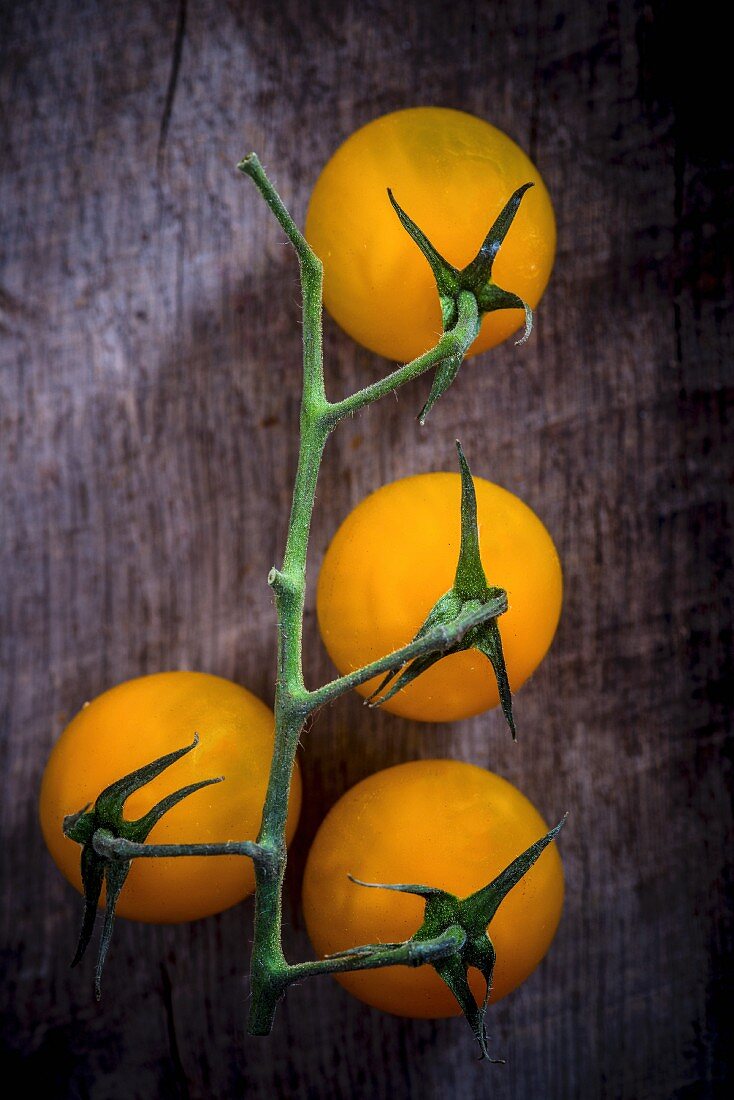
[352,814,568,1062]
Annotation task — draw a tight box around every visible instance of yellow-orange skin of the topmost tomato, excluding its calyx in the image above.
[305,107,556,361]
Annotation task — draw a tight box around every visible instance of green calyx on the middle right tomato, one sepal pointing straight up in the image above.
[368,440,517,740]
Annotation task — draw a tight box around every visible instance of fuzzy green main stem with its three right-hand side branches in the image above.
[238,154,488,1035]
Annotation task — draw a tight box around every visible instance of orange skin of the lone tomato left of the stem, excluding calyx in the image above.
[40,672,302,924]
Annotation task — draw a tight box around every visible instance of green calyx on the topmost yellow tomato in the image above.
[387,183,533,424]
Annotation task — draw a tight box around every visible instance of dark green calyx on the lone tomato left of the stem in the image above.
[64,736,221,1000]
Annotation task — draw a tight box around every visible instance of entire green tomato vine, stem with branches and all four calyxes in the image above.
[64,154,563,1056]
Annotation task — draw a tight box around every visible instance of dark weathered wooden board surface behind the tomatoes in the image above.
[0,0,734,1100]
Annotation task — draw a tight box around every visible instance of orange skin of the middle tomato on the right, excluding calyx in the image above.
[316,473,562,722]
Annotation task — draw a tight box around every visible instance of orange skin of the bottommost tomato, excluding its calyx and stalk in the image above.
[303,760,563,1019]
